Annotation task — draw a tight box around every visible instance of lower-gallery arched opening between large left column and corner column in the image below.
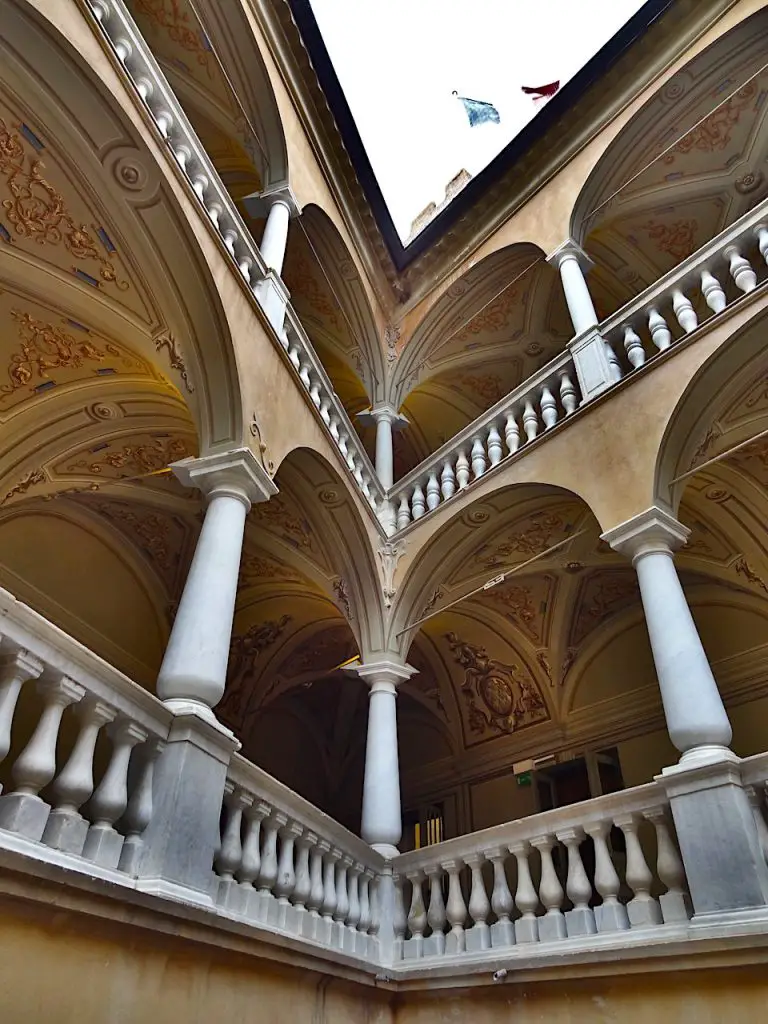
[217,450,381,828]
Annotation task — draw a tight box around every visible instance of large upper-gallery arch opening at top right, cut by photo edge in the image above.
[570,9,768,316]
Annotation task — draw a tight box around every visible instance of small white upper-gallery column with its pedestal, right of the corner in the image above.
[547,239,621,402]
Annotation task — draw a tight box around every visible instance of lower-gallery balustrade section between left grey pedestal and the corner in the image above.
[215,755,385,961]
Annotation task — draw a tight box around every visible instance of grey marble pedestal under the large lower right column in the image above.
[656,745,768,914]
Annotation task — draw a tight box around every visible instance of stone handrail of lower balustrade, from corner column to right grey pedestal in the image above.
[392,782,668,874]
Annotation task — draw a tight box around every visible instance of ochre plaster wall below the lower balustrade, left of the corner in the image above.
[0,902,391,1024]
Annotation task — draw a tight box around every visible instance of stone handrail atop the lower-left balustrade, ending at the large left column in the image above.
[0,588,167,738]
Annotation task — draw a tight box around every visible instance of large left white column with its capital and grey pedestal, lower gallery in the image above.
[138,449,278,903]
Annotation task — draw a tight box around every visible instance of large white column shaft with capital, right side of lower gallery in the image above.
[603,508,731,761]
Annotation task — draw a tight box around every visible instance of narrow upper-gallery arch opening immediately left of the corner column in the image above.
[283,203,384,403]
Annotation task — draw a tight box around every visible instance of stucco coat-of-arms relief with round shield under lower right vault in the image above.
[445,633,547,733]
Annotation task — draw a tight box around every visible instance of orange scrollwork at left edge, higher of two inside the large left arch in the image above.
[0,118,129,292]
